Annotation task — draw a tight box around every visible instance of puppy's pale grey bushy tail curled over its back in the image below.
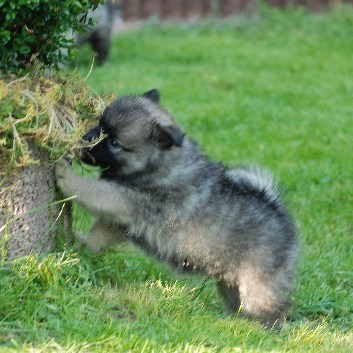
[227,166,279,202]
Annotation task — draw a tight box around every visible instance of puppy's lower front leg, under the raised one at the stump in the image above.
[79,219,126,253]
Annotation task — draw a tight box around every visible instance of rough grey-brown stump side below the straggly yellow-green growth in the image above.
[0,144,72,258]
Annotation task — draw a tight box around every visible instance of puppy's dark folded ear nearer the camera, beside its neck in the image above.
[151,123,185,150]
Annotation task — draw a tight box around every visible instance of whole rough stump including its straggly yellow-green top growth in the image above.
[0,72,110,257]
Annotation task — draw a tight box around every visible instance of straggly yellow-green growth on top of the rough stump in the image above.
[0,74,113,175]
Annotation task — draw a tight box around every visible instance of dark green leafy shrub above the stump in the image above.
[0,0,102,73]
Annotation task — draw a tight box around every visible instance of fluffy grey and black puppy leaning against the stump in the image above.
[56,90,297,327]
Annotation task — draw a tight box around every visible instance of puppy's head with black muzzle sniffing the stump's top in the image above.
[82,89,184,175]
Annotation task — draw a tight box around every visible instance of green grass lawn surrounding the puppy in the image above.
[0,7,353,353]
